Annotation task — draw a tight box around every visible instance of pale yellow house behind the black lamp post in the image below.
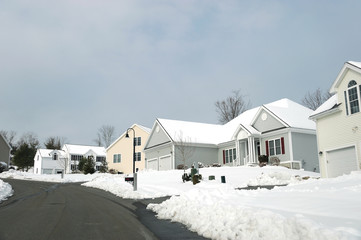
[106,124,151,174]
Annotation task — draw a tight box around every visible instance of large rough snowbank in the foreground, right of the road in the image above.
[148,173,361,239]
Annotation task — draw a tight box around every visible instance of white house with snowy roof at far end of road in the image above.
[34,144,106,174]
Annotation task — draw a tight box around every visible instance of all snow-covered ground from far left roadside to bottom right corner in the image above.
[0,167,361,239]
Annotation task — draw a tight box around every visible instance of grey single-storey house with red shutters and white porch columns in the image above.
[144,99,319,172]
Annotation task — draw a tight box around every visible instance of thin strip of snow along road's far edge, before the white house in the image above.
[0,169,104,183]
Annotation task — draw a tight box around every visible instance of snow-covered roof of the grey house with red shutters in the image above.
[157,98,316,145]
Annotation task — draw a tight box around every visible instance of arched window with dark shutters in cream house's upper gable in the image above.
[344,80,361,115]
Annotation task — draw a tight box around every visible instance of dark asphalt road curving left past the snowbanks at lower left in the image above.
[0,179,208,240]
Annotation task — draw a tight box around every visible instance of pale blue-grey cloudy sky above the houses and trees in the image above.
[0,0,361,145]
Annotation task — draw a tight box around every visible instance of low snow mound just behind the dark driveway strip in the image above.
[247,172,302,186]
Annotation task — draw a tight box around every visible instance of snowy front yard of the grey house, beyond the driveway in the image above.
[83,167,319,199]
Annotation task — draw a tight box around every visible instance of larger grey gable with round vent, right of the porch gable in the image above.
[252,109,285,133]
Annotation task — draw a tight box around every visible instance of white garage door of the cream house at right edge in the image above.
[327,147,357,177]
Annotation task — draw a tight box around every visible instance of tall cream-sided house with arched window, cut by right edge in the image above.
[310,61,361,177]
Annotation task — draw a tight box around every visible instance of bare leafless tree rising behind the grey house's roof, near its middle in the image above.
[215,90,251,124]
